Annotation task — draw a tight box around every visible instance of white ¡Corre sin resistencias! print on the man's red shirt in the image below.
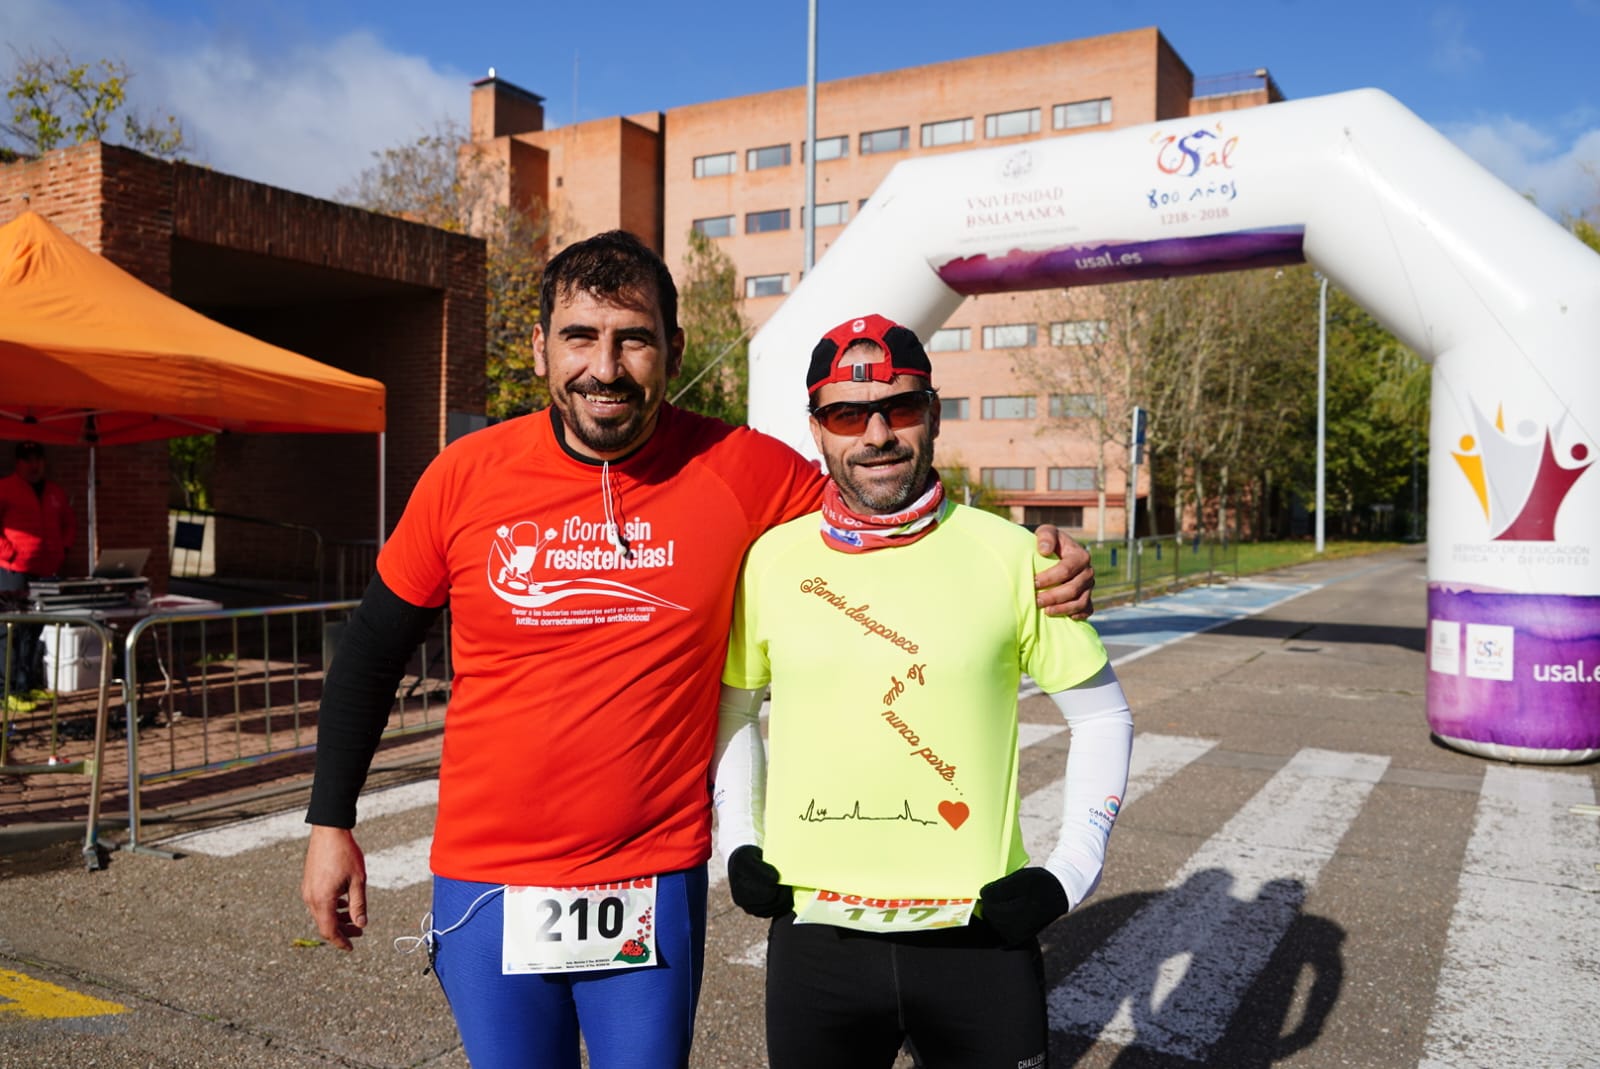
[488,515,683,610]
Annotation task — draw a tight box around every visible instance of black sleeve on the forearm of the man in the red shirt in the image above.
[306,575,443,827]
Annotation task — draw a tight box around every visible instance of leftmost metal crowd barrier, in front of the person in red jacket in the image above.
[0,613,117,871]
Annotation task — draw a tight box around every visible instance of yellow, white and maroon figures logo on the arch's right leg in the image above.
[1451,405,1594,543]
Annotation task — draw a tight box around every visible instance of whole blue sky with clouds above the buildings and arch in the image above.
[0,0,1600,214]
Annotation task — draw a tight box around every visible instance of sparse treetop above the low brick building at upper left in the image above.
[0,48,192,160]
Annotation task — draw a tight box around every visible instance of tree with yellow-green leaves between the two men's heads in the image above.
[672,230,750,426]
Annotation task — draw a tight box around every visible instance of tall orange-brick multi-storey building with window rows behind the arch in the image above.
[472,29,1282,536]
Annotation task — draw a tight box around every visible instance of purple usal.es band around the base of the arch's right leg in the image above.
[1427,583,1600,762]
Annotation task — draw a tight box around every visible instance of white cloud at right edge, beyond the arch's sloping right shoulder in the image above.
[1442,117,1600,219]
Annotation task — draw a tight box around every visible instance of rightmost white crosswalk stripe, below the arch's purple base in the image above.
[1419,765,1600,1069]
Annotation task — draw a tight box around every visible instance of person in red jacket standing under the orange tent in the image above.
[0,442,77,712]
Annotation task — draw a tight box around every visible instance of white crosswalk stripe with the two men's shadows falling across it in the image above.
[1050,741,1389,1061]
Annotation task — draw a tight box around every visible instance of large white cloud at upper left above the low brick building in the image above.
[0,0,472,197]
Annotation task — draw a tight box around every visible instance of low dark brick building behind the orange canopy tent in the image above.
[0,142,485,591]
